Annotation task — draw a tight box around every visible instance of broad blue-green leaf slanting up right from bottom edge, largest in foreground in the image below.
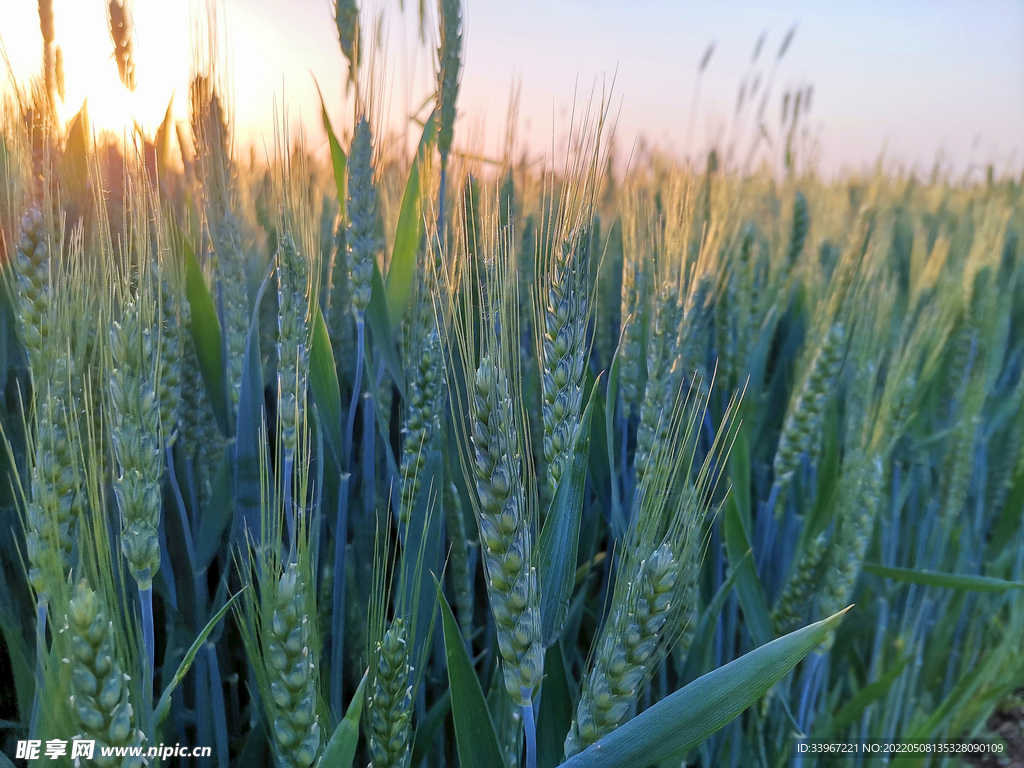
[563,610,846,768]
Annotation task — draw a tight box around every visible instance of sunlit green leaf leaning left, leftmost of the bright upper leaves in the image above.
[177,232,228,436]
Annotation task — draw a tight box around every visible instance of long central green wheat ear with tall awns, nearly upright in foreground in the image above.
[438,193,544,706]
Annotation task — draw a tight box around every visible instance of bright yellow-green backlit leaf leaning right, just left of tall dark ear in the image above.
[385,113,437,327]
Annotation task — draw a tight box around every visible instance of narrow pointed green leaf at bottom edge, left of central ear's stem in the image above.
[434,579,504,768]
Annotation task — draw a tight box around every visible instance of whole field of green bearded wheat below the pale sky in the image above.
[0,0,1024,768]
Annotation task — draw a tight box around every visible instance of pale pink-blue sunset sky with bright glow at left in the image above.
[0,0,1024,175]
